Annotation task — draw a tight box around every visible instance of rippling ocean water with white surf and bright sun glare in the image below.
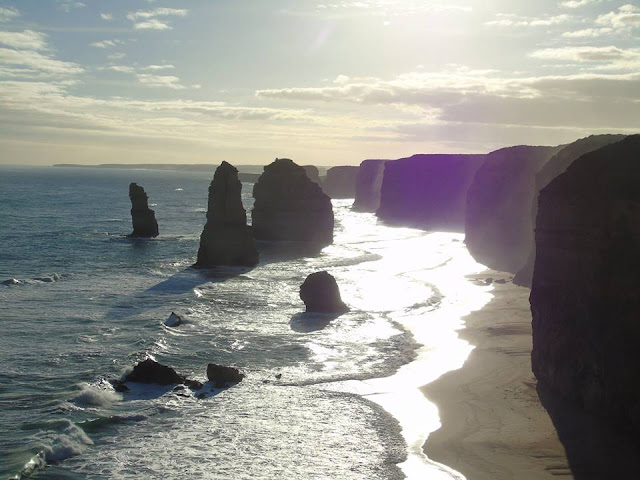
[0,167,489,479]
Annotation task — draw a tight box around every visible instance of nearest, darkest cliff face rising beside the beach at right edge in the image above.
[530,135,640,432]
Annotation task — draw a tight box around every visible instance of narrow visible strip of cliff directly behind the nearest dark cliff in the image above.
[513,135,625,287]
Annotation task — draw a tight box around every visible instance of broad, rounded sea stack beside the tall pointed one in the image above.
[251,158,334,245]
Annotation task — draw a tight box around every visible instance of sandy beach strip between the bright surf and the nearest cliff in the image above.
[421,270,574,480]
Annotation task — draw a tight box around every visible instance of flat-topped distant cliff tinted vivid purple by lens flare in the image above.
[376,155,484,232]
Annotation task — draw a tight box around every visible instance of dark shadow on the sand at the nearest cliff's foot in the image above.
[537,383,640,480]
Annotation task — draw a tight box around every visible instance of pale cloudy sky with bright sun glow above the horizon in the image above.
[0,0,640,166]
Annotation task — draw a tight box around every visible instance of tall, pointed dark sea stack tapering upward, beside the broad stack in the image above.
[194,162,258,268]
